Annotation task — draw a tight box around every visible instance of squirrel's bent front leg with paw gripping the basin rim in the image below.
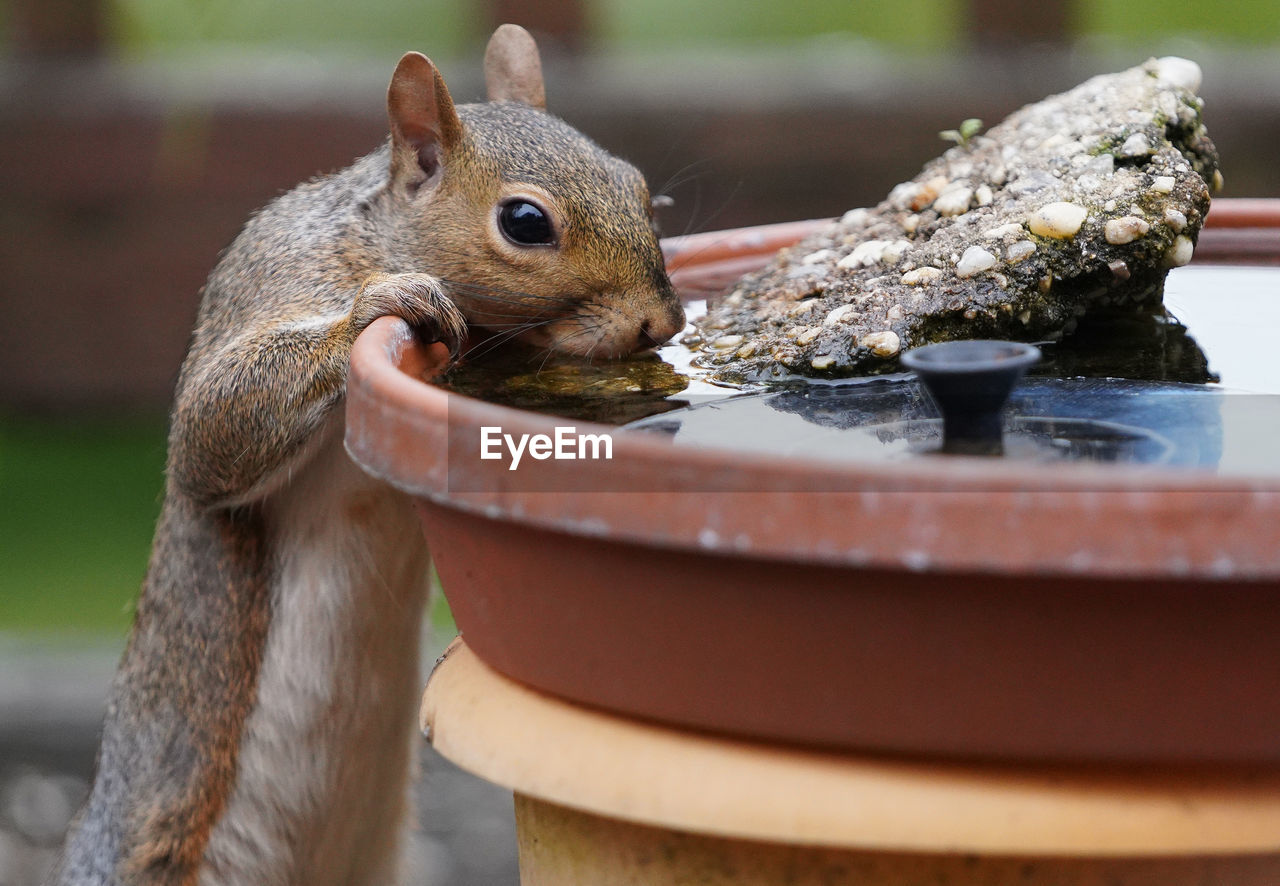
[169,274,466,506]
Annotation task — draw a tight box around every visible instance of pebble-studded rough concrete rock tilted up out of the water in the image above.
[689,59,1221,383]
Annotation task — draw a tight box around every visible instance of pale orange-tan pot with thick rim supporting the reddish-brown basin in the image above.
[422,641,1280,886]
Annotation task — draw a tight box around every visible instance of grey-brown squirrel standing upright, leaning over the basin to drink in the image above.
[50,24,684,886]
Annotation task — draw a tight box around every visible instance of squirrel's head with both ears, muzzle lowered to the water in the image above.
[388,24,685,357]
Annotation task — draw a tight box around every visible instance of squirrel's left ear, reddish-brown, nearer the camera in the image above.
[387,52,462,184]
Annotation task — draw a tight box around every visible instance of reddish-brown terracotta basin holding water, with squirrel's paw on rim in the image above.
[347,201,1280,766]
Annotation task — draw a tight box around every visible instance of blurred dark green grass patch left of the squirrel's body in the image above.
[0,417,165,635]
